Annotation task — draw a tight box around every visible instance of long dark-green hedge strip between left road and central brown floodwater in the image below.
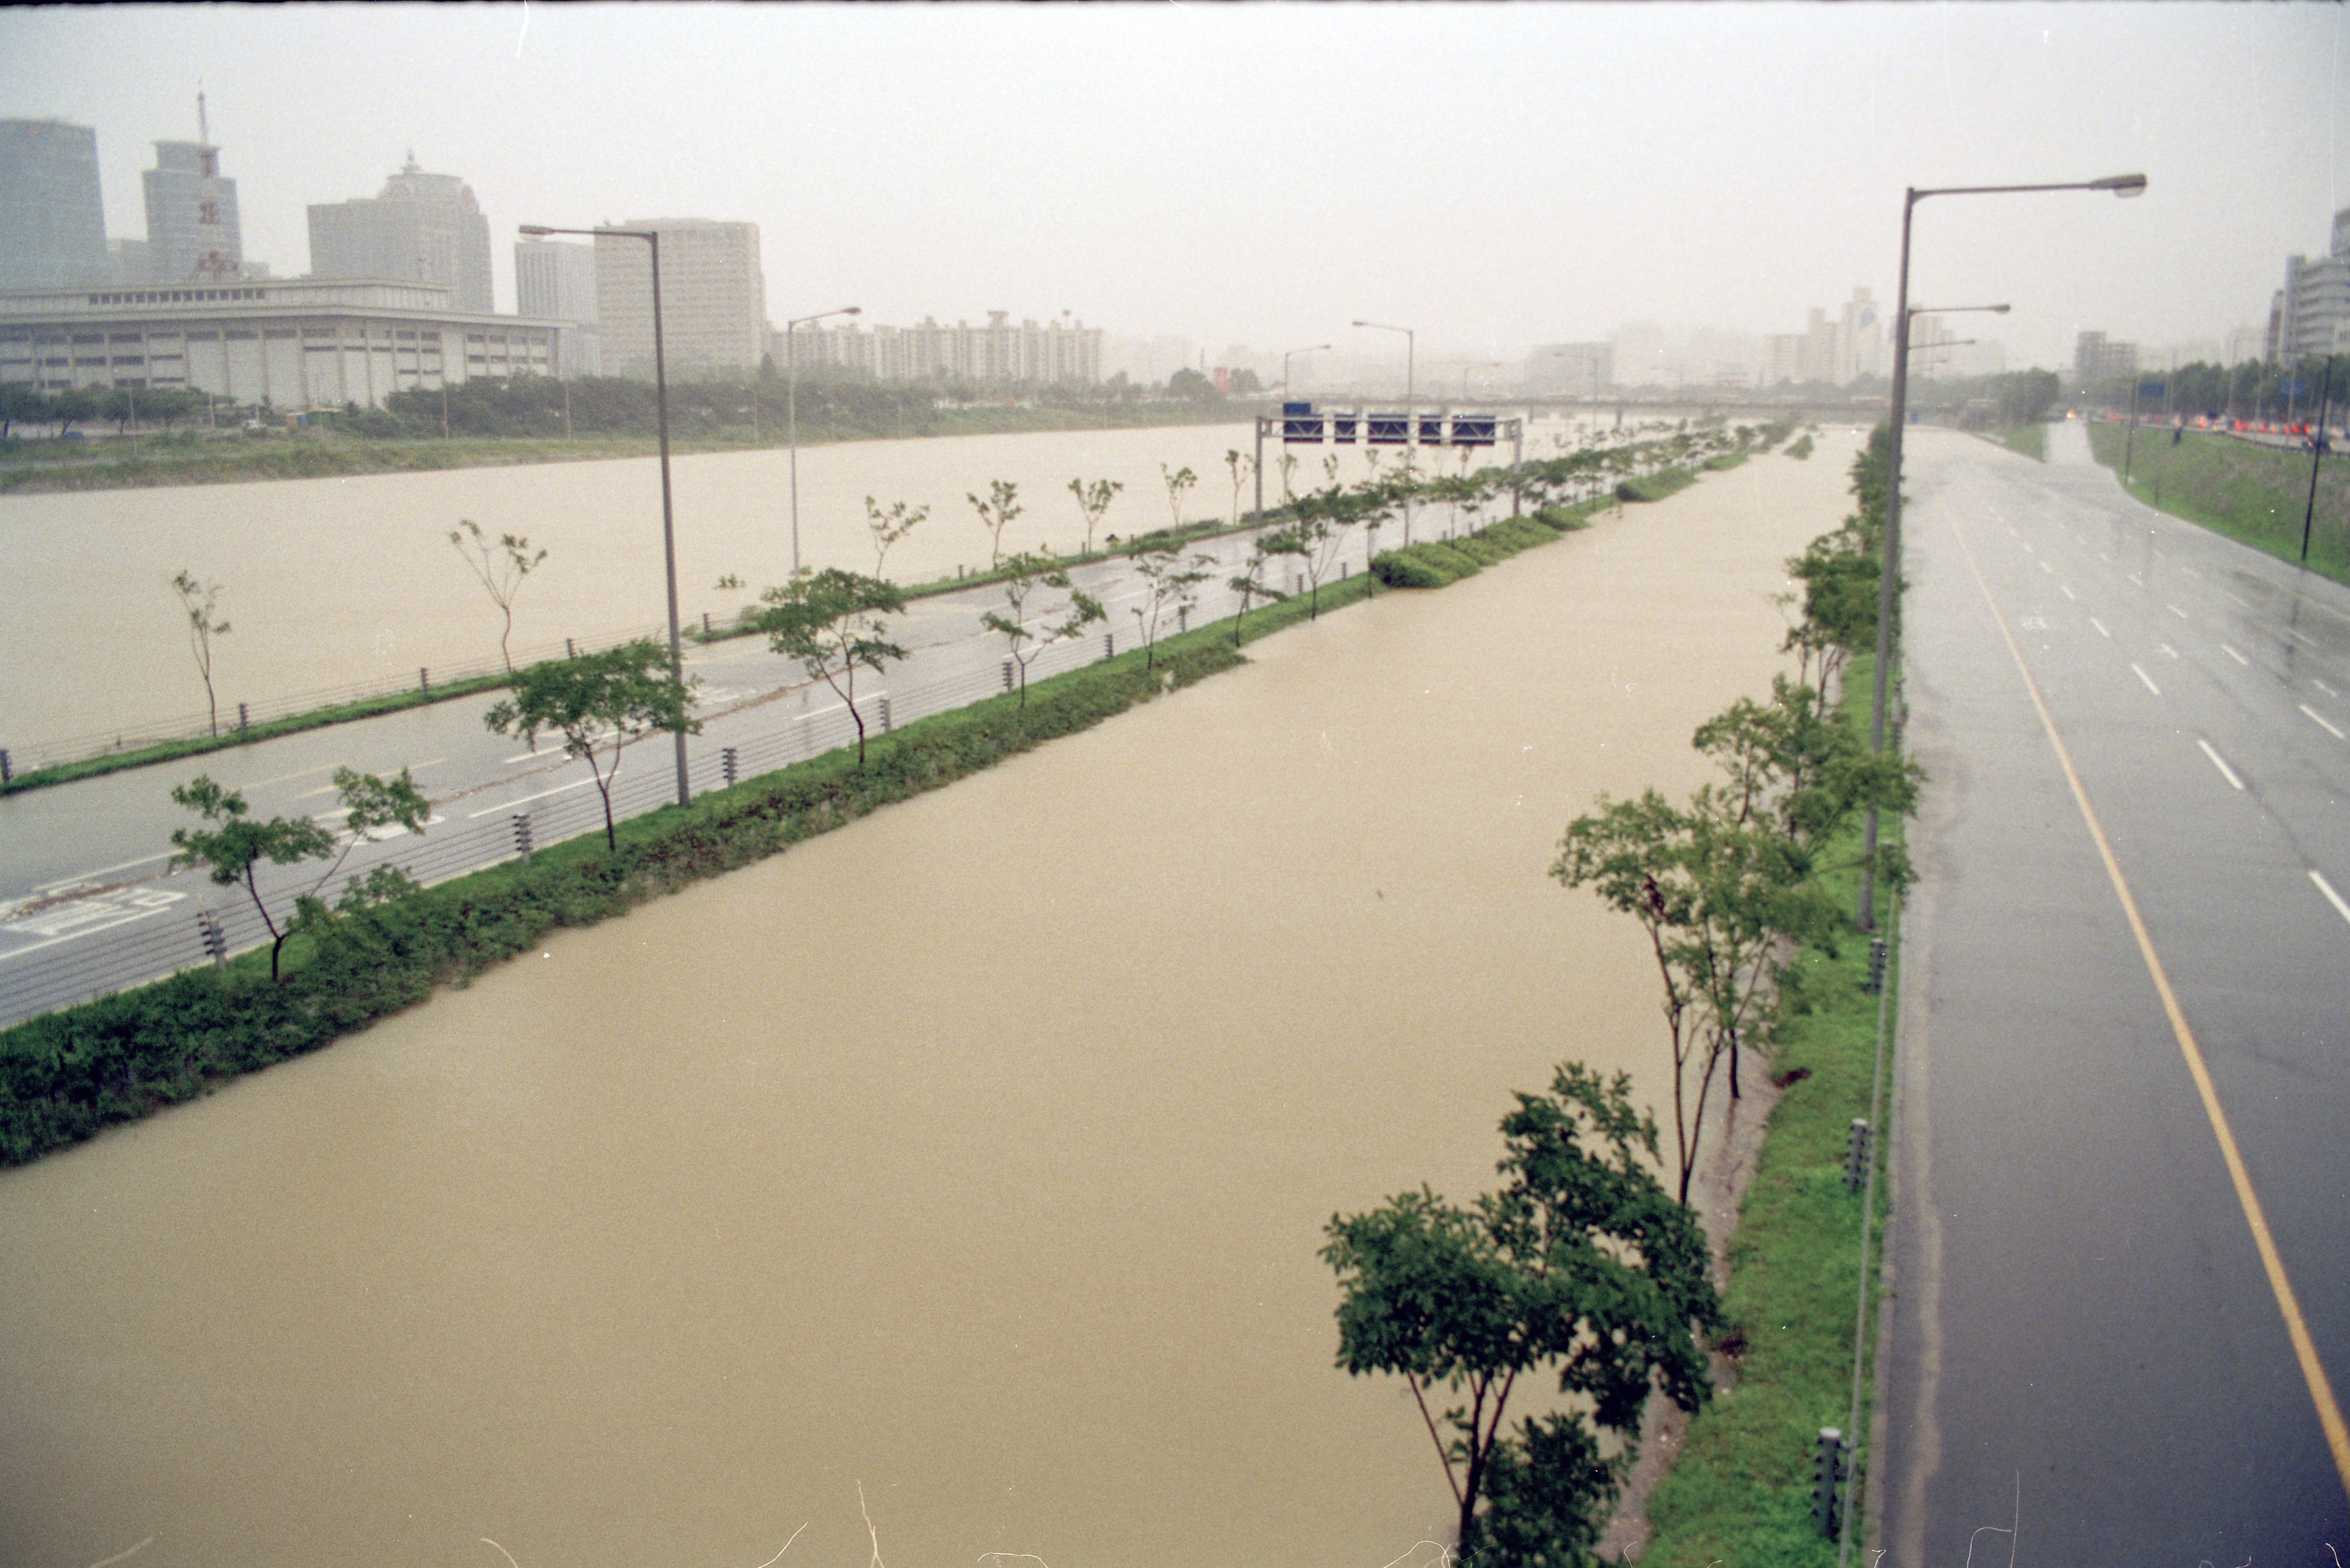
[0,491,1616,1166]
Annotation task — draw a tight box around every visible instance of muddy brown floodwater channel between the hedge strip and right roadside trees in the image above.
[0,433,1852,1568]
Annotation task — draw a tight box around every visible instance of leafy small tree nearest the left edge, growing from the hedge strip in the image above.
[171,769,433,985]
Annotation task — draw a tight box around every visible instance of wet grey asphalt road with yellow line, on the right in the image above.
[1889,426,2350,1568]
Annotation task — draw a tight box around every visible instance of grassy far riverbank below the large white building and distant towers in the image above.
[0,402,1255,494]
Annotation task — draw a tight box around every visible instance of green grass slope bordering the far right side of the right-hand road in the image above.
[2089,423,2350,583]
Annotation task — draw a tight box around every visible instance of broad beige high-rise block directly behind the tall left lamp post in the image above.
[595,219,766,378]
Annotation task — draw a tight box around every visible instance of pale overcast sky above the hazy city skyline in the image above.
[0,2,2350,364]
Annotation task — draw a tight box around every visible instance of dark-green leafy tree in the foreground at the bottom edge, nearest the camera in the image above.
[1323,1062,1723,1568]
